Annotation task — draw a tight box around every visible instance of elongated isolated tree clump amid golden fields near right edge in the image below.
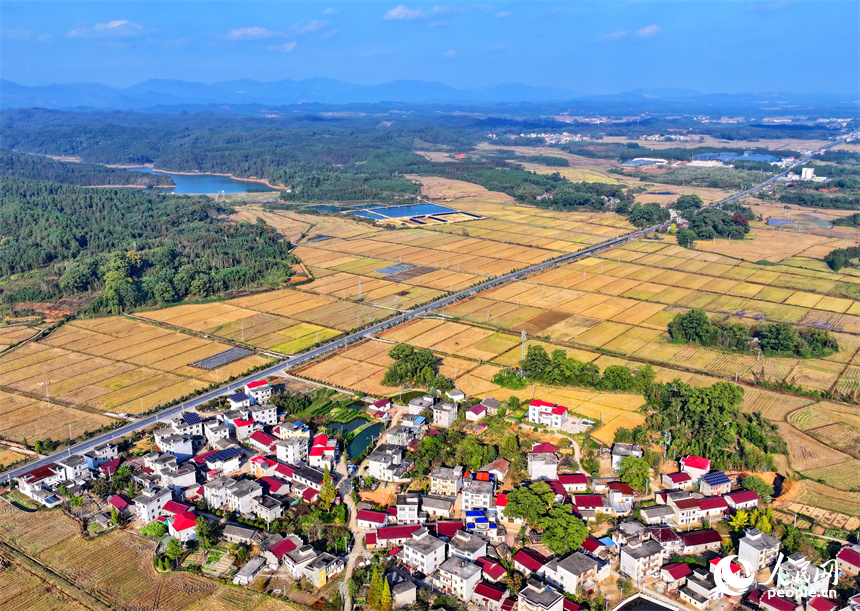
[668,308,839,359]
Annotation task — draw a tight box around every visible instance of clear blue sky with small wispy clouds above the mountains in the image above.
[0,0,860,94]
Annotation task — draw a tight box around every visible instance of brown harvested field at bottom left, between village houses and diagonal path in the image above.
[0,504,292,611]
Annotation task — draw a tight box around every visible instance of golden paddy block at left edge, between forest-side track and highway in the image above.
[0,317,267,441]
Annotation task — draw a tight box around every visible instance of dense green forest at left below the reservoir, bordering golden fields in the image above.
[0,178,295,311]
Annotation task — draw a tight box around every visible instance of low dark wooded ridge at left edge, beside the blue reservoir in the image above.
[0,149,173,187]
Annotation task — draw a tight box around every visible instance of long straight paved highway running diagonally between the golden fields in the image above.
[0,141,840,481]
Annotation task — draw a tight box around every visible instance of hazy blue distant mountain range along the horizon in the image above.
[0,78,848,110]
